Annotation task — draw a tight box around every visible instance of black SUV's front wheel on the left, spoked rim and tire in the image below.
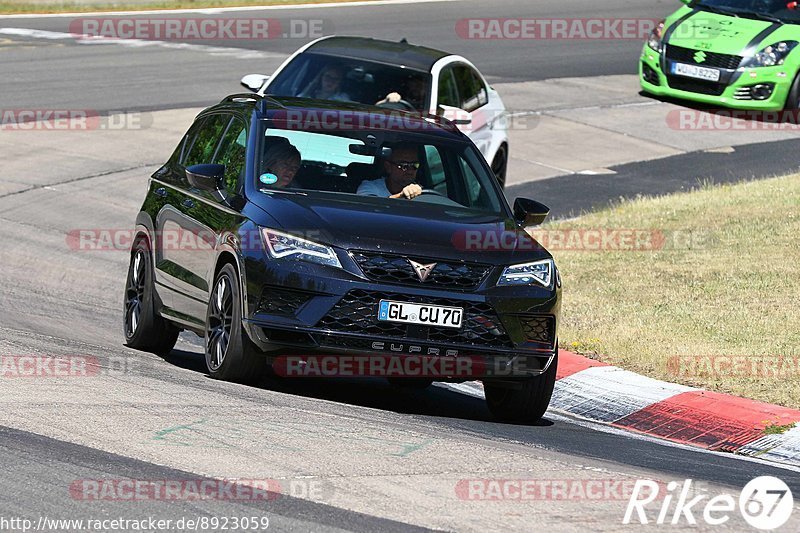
[205,263,266,383]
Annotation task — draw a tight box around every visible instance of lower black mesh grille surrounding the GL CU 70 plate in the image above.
[317,289,514,348]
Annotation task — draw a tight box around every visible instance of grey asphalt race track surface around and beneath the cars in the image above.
[0,0,800,531]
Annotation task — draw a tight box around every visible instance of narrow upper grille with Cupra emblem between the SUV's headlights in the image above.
[353,252,491,290]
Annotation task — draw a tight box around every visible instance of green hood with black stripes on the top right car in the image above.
[664,6,800,55]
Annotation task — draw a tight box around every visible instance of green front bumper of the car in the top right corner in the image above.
[639,44,794,111]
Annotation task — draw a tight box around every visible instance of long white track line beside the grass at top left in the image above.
[0,0,463,20]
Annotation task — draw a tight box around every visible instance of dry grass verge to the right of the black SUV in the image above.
[542,175,800,408]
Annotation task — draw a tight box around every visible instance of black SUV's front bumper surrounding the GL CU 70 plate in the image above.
[243,251,560,381]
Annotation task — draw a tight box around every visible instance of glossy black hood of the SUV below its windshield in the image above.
[251,192,551,265]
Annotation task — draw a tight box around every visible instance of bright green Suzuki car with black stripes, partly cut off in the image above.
[639,0,800,111]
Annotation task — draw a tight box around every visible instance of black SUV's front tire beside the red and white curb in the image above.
[483,349,558,424]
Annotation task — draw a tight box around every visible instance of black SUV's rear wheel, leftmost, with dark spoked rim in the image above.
[122,239,181,356]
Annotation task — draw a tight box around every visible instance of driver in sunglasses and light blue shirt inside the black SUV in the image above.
[356,144,422,200]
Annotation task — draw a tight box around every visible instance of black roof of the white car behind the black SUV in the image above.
[305,36,452,72]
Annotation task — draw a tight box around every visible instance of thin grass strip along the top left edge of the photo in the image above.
[0,0,358,15]
